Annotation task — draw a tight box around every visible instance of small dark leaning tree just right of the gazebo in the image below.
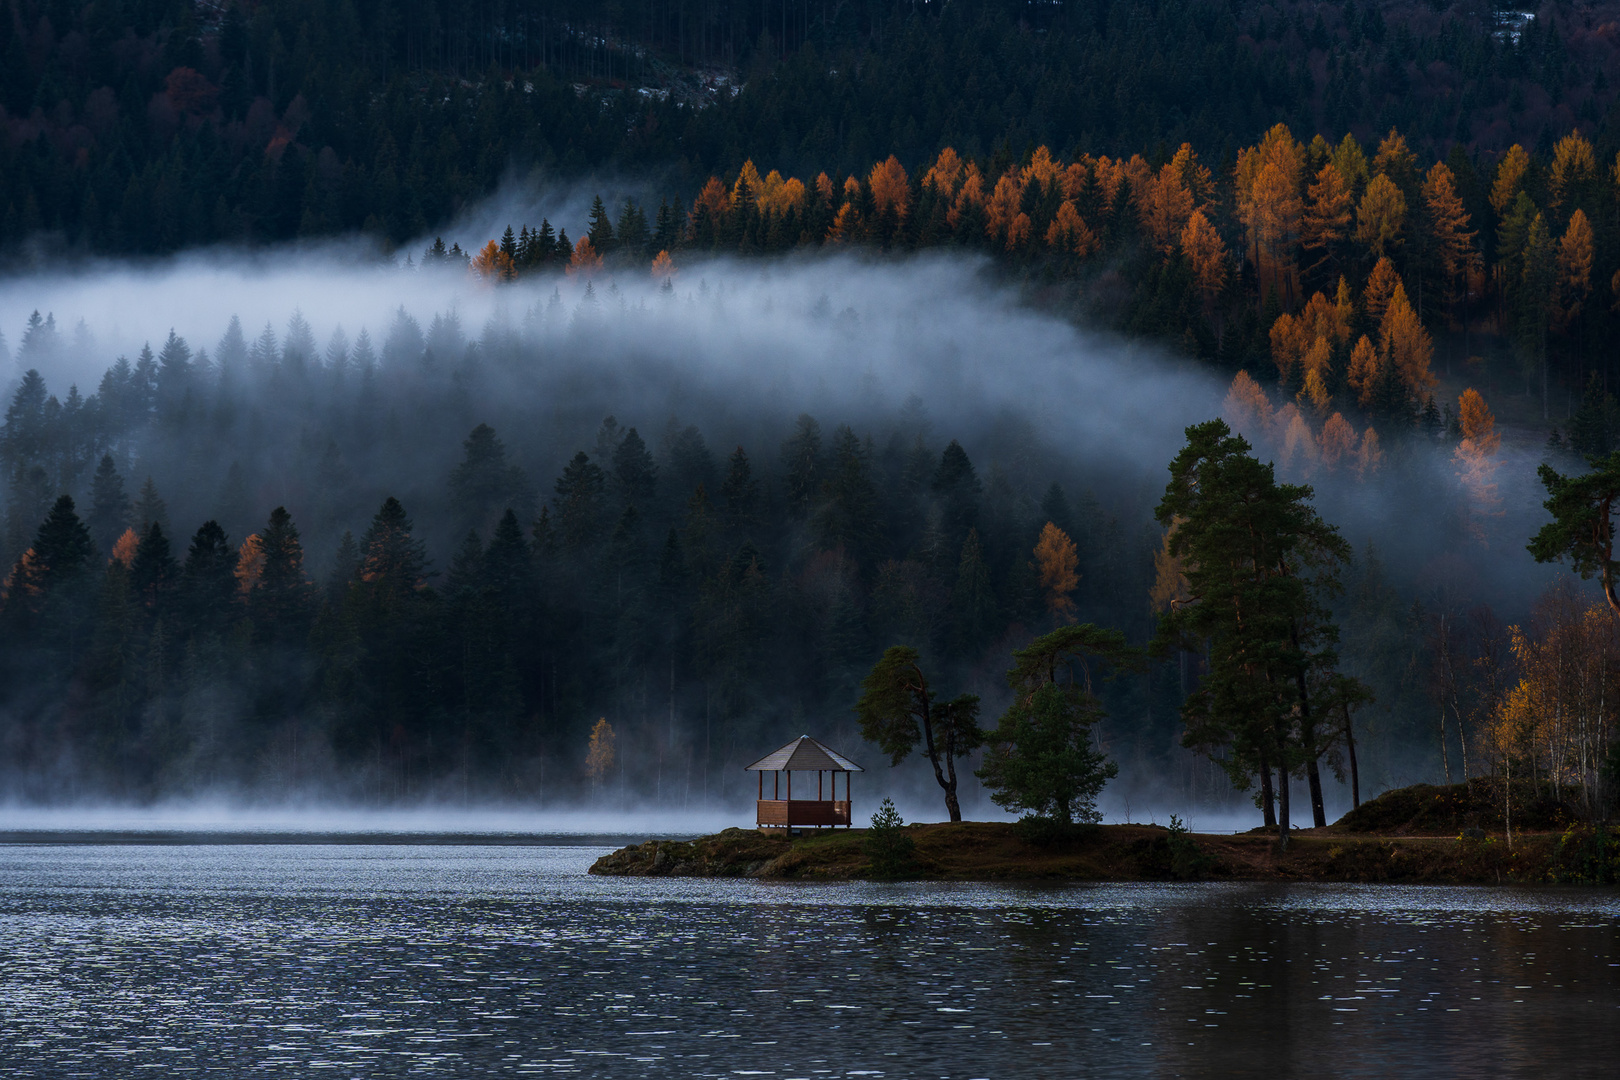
[855,644,983,821]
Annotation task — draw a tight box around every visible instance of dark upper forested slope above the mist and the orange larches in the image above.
[0,0,1620,253]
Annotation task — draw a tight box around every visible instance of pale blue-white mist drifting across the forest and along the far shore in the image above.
[0,233,1557,834]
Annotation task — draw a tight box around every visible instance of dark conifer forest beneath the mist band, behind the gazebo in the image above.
[0,286,1175,800]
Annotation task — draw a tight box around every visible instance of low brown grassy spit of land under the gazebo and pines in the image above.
[590,785,1620,884]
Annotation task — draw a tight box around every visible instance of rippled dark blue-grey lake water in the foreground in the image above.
[0,844,1620,1078]
